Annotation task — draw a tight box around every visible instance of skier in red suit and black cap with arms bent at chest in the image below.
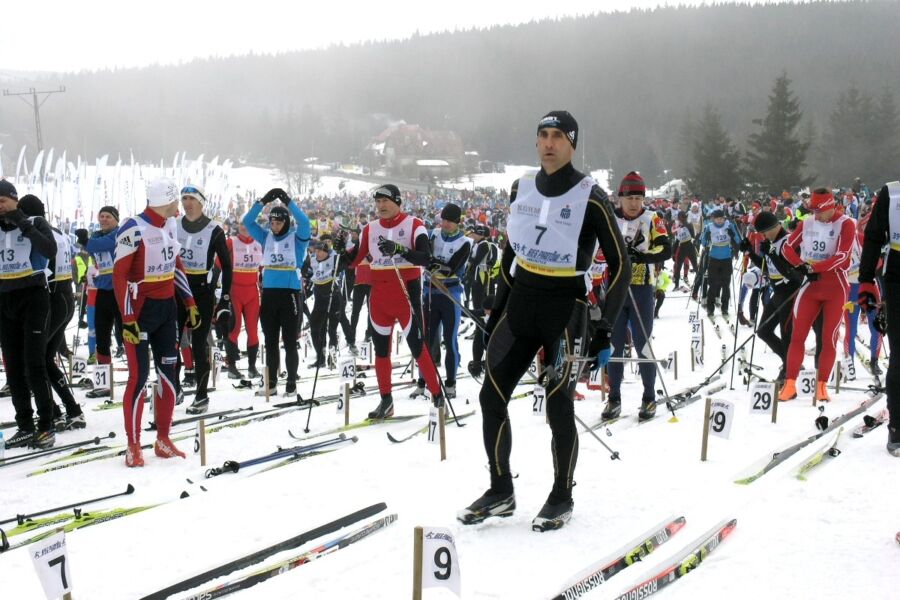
[348,184,443,419]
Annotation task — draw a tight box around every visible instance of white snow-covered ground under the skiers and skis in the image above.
[0,268,900,600]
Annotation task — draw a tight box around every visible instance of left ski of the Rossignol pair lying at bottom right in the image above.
[551,517,685,600]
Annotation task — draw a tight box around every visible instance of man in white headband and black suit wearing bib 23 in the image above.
[175,184,232,415]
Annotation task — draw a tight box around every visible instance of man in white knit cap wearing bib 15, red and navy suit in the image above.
[113,178,201,467]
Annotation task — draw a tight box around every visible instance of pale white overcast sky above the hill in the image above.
[0,0,780,71]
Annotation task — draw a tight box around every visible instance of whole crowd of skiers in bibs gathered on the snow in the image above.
[0,111,900,531]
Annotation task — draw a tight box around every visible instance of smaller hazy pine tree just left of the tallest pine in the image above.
[688,104,742,198]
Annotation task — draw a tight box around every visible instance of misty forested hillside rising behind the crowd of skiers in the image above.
[0,1,900,192]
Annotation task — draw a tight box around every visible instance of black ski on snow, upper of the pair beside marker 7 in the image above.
[141,502,387,600]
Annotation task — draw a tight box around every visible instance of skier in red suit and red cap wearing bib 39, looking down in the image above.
[778,188,856,402]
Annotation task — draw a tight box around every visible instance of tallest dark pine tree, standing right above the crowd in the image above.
[747,73,811,192]
